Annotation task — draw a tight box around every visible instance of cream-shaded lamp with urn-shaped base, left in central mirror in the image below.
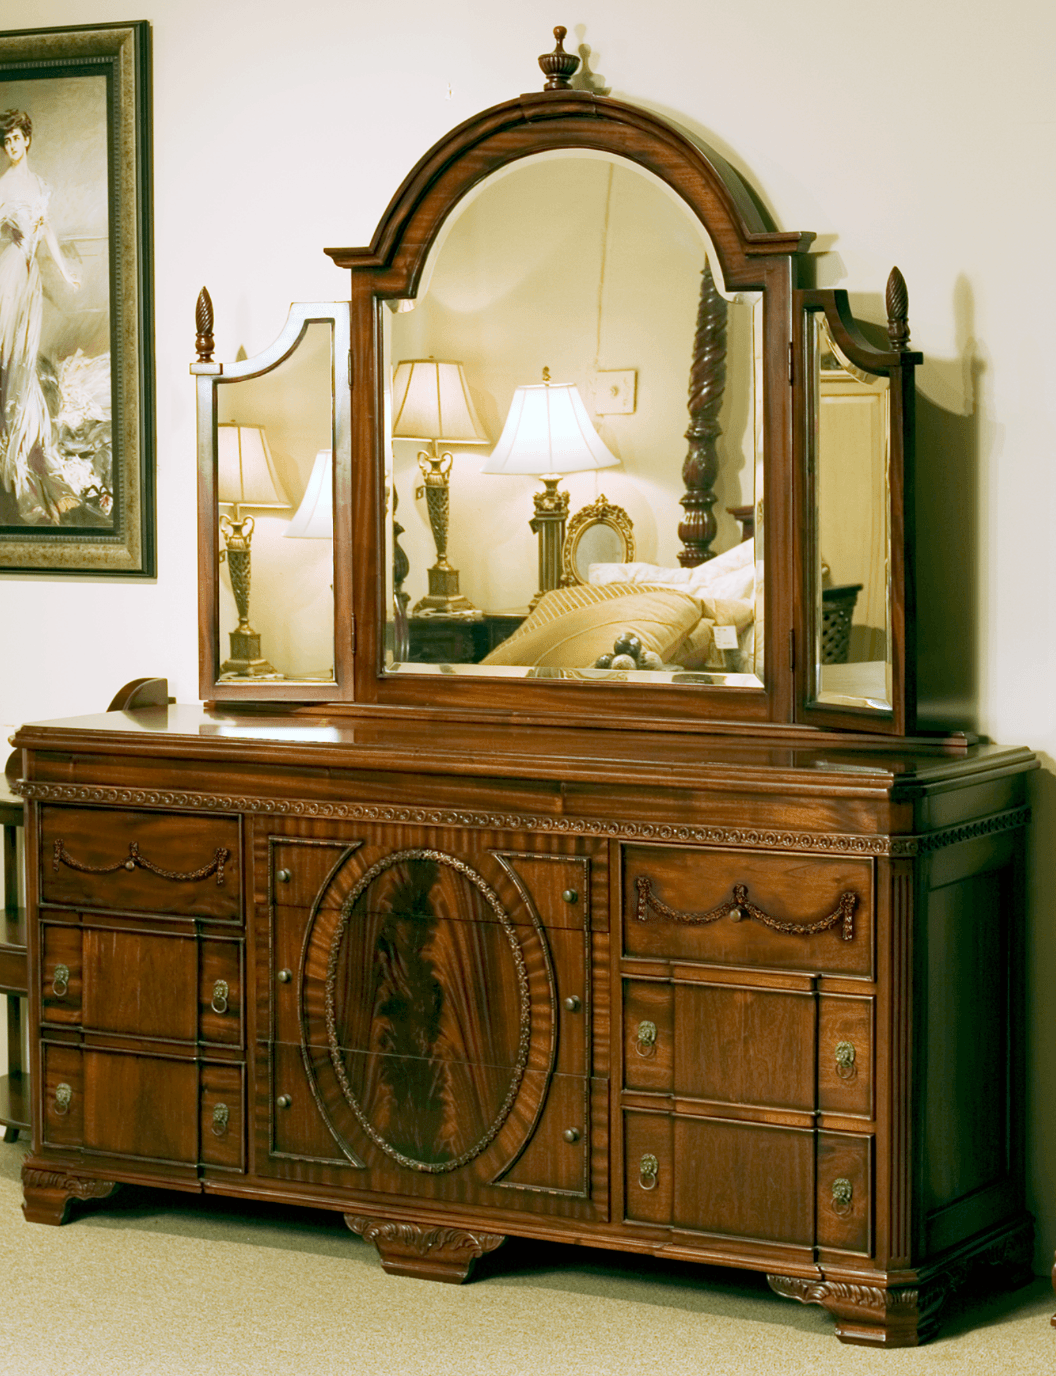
[392,358,489,616]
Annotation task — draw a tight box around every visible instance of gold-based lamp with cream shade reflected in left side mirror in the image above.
[216,421,291,678]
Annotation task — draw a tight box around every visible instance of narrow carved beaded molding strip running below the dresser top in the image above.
[12,779,1030,859]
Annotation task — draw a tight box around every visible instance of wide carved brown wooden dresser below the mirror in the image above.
[15,707,1034,1346]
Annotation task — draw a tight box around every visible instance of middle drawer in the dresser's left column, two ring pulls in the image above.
[40,919,242,1046]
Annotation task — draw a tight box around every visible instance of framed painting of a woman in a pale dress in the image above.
[0,22,156,578]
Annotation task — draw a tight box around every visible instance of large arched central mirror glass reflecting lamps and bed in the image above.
[384,150,764,687]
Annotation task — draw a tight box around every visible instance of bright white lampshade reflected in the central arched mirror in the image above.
[482,383,620,476]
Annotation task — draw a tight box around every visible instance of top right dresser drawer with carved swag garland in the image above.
[622,846,873,977]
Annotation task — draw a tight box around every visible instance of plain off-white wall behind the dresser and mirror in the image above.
[0,0,1056,1266]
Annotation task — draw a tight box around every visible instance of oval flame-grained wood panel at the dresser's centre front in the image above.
[325,849,531,1174]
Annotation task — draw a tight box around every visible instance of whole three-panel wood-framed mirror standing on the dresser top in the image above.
[193,26,920,735]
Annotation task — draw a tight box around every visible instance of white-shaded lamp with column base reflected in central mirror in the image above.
[481,367,620,608]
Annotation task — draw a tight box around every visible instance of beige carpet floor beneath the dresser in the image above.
[0,1142,1056,1376]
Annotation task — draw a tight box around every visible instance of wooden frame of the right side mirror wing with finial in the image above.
[793,268,922,736]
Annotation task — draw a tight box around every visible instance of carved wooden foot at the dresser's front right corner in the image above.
[767,1276,946,1347]
